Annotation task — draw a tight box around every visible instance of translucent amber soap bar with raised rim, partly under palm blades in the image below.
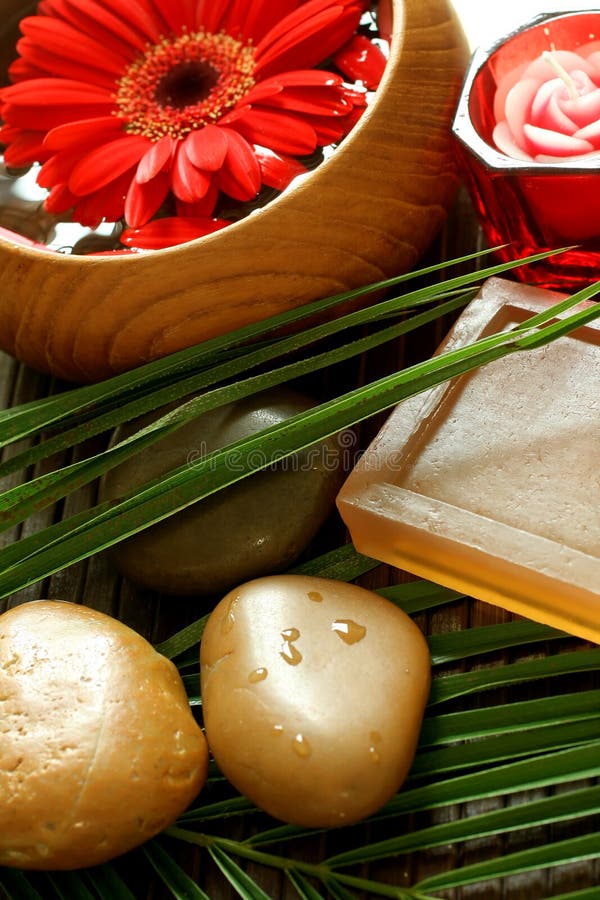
[338,278,600,642]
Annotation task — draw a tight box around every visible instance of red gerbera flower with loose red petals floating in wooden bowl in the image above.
[0,0,384,246]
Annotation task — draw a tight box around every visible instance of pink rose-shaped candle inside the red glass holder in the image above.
[493,41,600,163]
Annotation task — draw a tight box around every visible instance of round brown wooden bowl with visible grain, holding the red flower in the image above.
[0,0,468,381]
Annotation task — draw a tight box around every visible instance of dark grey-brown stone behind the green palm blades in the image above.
[101,388,344,595]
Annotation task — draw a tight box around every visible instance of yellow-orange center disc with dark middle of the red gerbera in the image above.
[115,31,255,141]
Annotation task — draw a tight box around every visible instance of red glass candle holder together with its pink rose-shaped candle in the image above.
[452,10,600,290]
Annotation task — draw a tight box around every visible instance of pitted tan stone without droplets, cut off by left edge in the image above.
[0,600,208,869]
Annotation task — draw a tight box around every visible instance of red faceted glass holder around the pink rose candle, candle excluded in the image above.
[453,9,600,289]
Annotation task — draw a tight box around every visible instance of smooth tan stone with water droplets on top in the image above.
[200,575,430,827]
